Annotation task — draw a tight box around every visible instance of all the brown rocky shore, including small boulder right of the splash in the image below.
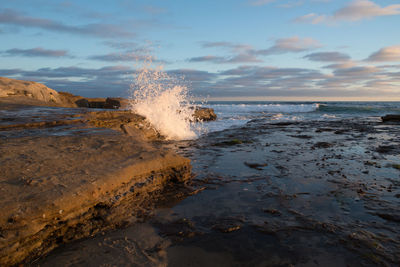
[0,78,215,266]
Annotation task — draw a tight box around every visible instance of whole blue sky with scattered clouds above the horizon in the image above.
[0,0,400,101]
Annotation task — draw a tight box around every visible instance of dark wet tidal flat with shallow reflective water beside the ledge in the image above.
[37,117,400,266]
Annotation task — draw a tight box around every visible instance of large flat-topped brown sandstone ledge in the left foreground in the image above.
[0,133,191,266]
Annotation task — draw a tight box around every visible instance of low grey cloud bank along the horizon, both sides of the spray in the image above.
[0,60,400,98]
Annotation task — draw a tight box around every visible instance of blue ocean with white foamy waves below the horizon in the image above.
[200,101,400,132]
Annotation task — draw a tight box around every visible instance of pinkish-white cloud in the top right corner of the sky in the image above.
[294,0,400,24]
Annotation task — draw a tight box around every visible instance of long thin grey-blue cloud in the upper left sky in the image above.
[0,9,135,38]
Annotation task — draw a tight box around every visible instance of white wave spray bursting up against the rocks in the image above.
[131,62,197,140]
